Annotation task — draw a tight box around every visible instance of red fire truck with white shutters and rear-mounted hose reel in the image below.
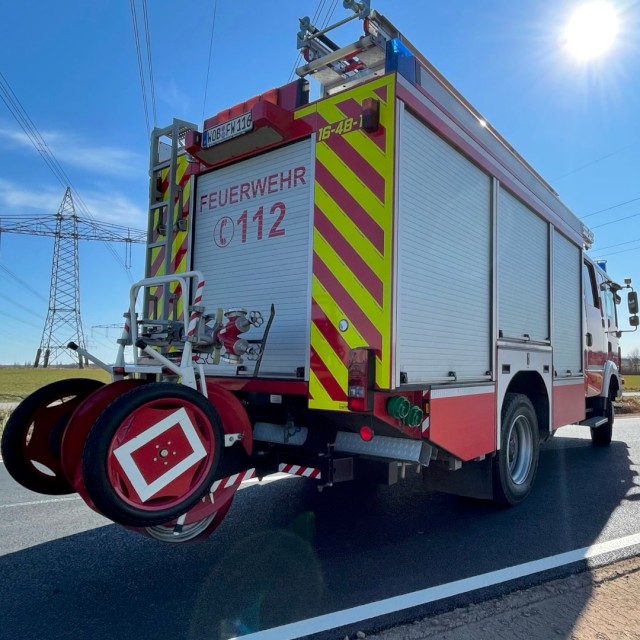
[2,2,638,542]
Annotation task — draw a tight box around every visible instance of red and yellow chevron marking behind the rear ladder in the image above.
[147,155,191,319]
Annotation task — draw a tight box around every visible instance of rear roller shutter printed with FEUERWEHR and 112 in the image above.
[193,139,313,377]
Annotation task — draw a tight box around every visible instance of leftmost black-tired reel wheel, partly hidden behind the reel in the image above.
[1,378,103,496]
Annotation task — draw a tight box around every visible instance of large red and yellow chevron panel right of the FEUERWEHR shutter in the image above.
[296,76,395,411]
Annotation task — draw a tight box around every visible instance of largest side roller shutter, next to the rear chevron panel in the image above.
[396,113,491,382]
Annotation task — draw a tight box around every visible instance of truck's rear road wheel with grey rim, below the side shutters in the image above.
[493,393,540,506]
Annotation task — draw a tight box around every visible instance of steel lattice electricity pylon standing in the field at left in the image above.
[0,187,146,368]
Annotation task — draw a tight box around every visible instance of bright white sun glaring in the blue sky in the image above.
[564,0,618,61]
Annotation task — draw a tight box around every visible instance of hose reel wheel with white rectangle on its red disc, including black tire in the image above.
[82,382,224,527]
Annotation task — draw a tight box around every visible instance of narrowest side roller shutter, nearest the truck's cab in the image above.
[553,231,582,376]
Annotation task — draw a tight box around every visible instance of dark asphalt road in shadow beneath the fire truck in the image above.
[0,418,640,640]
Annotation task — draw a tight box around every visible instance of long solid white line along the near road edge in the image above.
[232,534,640,640]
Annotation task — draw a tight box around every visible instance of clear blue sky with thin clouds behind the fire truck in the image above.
[0,0,640,363]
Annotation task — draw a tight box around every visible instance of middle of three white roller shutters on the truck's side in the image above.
[498,189,550,341]
